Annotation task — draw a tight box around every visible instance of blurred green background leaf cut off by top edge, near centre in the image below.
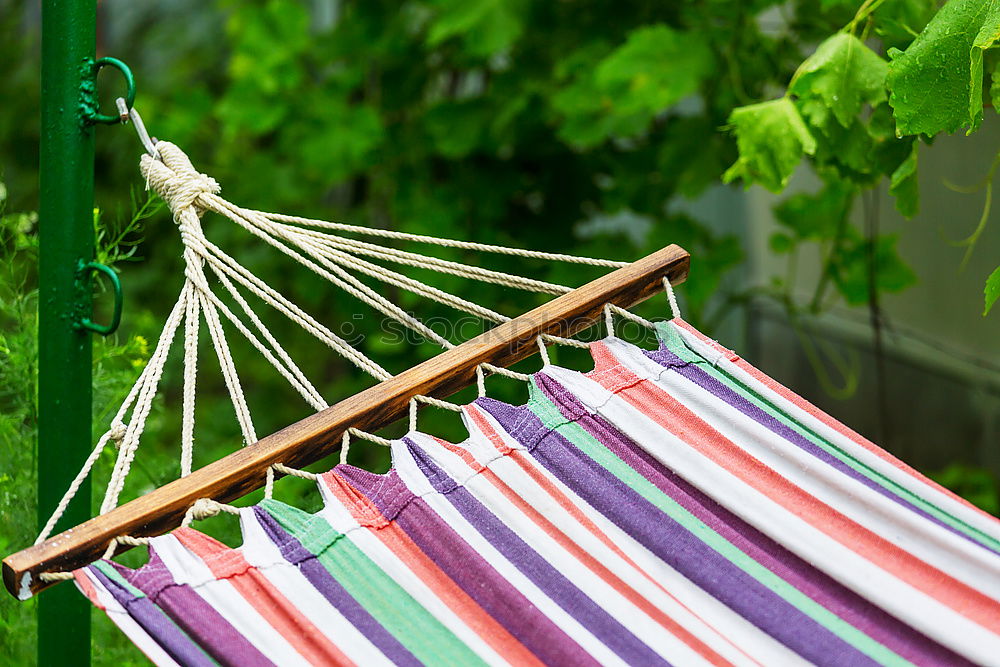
[427,0,524,57]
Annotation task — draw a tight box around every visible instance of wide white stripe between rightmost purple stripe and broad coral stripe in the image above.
[605,339,1000,599]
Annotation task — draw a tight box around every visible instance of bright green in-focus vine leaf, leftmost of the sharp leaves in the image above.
[722,97,816,192]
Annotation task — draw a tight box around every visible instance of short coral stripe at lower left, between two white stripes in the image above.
[173,528,354,665]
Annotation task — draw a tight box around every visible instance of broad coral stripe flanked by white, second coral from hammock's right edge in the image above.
[592,343,1000,632]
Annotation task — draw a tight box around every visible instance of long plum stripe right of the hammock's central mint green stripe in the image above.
[539,377,971,665]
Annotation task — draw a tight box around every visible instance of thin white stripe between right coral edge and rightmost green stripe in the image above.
[671,324,1000,541]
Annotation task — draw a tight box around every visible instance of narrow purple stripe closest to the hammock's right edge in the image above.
[641,338,1000,553]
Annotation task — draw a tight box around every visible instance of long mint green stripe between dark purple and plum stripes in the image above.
[527,382,911,665]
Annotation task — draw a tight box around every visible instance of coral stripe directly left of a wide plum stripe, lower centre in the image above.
[322,472,542,665]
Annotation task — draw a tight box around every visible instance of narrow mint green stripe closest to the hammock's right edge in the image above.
[656,322,1000,553]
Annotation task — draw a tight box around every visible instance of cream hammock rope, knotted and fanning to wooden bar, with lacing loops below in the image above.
[35,141,656,560]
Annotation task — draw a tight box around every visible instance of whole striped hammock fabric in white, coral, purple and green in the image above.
[75,320,1000,666]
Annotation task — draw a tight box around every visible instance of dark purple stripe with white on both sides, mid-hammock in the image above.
[403,438,668,665]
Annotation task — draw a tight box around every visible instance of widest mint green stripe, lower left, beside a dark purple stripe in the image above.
[260,500,485,665]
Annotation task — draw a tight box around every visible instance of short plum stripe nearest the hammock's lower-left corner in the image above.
[123,545,274,667]
